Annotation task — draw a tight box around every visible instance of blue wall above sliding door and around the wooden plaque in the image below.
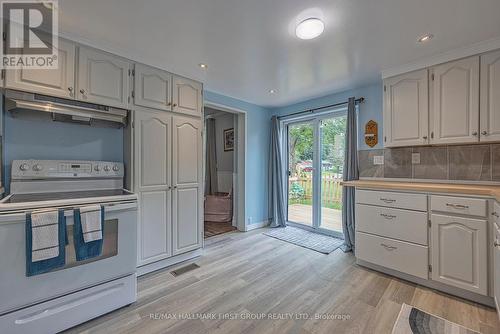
[272,82,383,150]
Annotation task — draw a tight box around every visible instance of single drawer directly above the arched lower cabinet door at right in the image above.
[431,195,487,217]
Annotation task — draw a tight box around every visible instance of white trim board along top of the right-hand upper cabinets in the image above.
[382,37,500,79]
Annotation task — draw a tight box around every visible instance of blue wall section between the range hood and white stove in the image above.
[3,112,123,189]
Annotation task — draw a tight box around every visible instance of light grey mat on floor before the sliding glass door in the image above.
[264,226,344,254]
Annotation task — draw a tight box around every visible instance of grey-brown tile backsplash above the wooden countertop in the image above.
[358,144,500,182]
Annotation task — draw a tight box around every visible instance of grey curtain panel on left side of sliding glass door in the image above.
[269,116,286,227]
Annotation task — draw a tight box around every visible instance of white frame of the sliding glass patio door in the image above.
[280,107,347,238]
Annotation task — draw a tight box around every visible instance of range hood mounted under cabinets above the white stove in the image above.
[5,90,127,128]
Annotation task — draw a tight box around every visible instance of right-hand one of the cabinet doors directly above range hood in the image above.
[77,47,129,109]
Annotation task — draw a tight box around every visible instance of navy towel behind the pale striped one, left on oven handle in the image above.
[26,209,66,277]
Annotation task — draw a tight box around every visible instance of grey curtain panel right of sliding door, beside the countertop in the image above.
[342,97,359,252]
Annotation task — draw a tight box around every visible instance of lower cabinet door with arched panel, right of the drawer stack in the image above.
[431,214,488,295]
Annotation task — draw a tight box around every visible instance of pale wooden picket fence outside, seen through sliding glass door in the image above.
[288,175,342,203]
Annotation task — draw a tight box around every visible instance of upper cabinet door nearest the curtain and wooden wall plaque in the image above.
[384,69,429,147]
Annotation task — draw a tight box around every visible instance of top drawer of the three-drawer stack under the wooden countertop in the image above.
[356,190,427,211]
